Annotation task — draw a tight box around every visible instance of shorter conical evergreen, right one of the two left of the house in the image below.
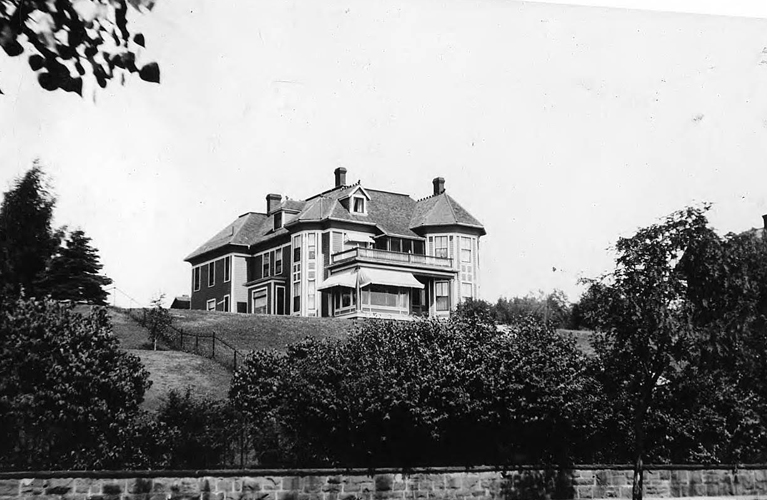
[43,229,112,305]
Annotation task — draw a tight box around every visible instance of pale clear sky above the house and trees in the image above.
[0,0,767,306]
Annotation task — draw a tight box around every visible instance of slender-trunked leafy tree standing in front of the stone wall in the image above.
[589,206,710,499]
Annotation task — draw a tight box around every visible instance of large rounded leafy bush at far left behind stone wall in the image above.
[0,299,149,470]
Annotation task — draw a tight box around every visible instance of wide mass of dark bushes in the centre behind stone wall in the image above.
[230,315,590,467]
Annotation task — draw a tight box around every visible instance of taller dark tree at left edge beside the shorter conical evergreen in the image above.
[0,163,60,297]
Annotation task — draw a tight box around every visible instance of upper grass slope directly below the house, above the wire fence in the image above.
[166,310,355,354]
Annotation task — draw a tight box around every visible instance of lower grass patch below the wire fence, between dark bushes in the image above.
[128,349,232,411]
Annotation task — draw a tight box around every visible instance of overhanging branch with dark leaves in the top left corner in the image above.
[0,0,160,95]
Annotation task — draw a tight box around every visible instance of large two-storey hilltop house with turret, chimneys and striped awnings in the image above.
[185,167,486,318]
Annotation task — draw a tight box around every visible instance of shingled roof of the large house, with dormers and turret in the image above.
[184,177,485,261]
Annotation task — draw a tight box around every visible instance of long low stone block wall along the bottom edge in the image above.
[0,466,767,500]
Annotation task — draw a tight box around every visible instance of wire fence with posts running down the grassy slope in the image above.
[128,308,245,371]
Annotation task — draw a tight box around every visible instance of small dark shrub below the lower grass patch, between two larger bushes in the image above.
[157,389,246,470]
